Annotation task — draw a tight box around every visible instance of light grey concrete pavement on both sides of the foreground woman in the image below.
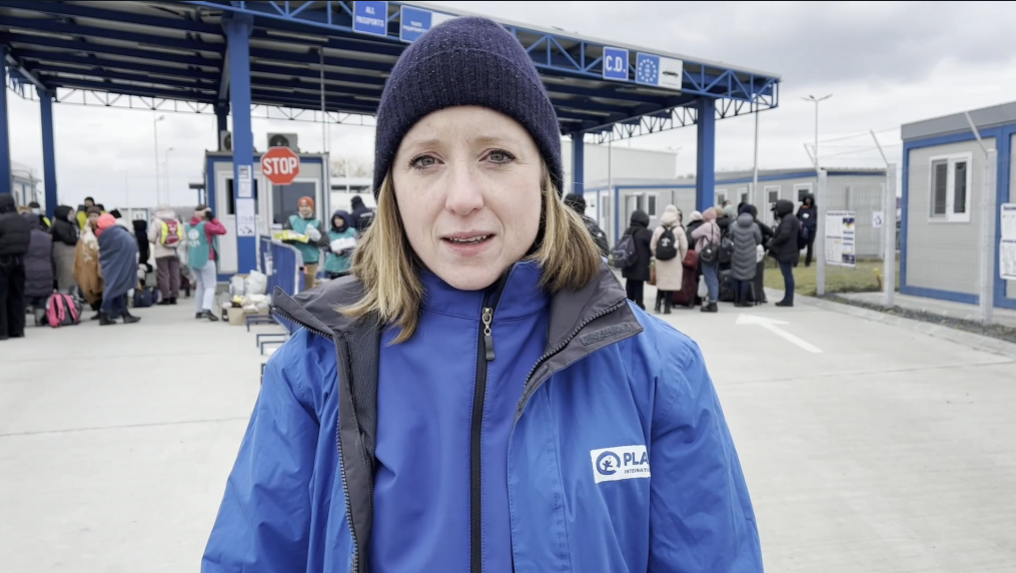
[0,288,1016,573]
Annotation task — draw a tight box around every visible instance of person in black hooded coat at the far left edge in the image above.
[0,193,31,340]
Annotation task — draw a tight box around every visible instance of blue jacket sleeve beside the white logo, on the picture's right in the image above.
[648,340,763,573]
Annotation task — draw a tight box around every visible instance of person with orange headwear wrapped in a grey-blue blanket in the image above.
[96,213,141,326]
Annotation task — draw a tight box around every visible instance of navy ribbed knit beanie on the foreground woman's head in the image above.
[374,16,564,199]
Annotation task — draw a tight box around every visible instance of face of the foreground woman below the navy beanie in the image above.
[392,107,543,291]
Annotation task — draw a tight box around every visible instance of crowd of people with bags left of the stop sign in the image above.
[0,195,232,340]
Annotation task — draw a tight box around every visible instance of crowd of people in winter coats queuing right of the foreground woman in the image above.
[609,195,817,314]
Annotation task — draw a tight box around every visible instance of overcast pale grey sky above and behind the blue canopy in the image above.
[8,2,1016,206]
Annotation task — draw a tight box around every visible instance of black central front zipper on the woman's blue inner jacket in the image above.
[469,276,507,573]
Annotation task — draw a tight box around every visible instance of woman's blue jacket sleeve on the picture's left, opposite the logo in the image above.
[201,330,319,573]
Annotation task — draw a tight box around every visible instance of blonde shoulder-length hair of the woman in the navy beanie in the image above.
[336,170,600,343]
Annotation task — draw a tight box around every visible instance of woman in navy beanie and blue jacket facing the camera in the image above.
[202,17,762,573]
